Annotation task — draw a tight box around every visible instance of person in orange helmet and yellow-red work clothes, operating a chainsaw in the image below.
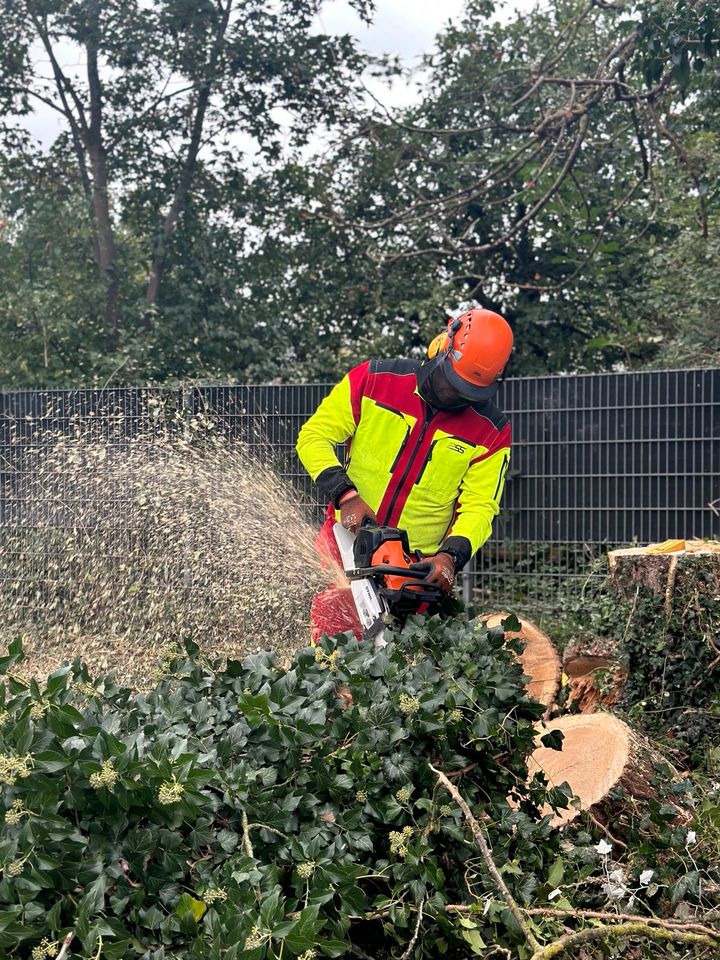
[297,309,513,639]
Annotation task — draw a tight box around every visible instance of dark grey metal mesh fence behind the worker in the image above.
[0,369,720,610]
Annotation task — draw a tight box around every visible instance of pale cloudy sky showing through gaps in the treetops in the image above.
[24,0,536,147]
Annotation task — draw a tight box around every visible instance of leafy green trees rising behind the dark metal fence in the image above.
[0,0,720,386]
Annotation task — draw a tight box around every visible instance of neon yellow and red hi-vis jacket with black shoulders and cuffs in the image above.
[297,360,510,569]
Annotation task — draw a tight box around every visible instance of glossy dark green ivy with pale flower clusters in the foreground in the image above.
[0,618,567,960]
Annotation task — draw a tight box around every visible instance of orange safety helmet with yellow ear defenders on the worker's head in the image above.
[428,308,513,402]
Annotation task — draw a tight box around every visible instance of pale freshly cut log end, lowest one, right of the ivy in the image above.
[528,713,684,827]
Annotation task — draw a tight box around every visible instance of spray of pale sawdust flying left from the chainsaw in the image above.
[0,422,344,685]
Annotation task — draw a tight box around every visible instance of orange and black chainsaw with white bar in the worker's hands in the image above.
[333,522,443,646]
